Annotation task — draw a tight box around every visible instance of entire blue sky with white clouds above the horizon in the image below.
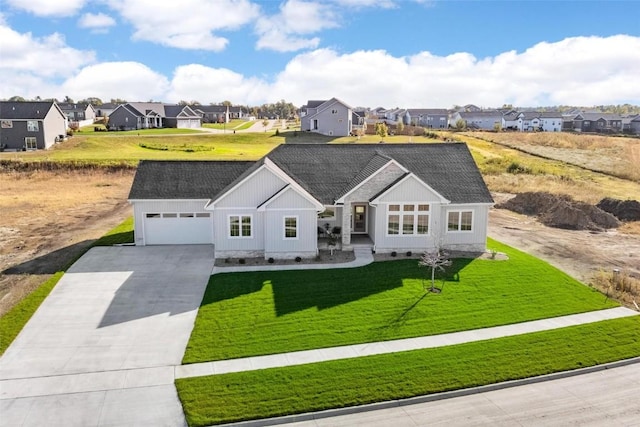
[0,0,640,108]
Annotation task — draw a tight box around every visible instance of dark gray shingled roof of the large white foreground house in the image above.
[129,143,493,205]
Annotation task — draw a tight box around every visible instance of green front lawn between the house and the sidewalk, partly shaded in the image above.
[183,240,618,363]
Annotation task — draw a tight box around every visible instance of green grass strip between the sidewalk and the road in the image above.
[176,316,640,426]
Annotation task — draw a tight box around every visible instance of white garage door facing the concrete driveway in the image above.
[144,212,213,245]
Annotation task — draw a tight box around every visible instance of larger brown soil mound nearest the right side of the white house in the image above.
[496,192,620,231]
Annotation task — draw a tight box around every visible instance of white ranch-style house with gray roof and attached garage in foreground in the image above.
[129,143,493,259]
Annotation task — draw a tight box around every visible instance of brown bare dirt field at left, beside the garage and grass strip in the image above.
[0,170,133,315]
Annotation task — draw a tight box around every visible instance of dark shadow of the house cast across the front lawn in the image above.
[202,259,472,320]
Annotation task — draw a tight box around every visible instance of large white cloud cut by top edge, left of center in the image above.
[107,0,259,51]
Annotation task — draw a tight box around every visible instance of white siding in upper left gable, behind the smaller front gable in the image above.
[215,167,286,209]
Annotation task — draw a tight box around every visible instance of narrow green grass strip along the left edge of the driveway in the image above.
[0,217,133,355]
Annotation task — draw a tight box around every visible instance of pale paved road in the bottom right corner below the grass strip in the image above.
[286,363,640,427]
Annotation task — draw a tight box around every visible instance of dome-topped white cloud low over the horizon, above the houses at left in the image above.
[62,62,169,101]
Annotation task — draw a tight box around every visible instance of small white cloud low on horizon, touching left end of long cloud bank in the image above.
[167,64,269,105]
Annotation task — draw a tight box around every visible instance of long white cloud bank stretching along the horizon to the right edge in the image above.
[270,35,640,107]
